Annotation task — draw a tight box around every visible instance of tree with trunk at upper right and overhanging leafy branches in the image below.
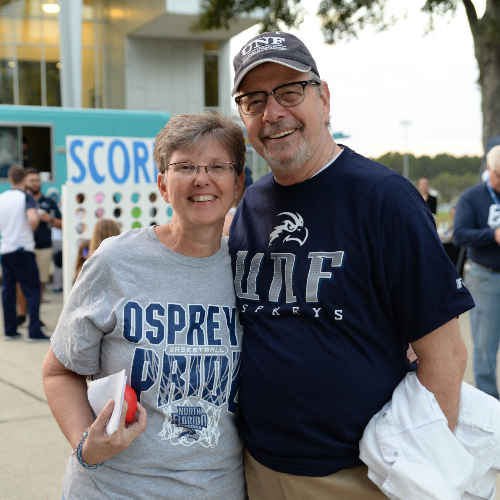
[196,0,500,150]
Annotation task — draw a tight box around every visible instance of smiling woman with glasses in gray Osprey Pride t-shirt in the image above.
[43,113,246,500]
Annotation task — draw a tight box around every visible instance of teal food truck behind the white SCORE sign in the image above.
[0,105,170,193]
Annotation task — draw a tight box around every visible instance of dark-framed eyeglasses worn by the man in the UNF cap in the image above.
[234,80,318,115]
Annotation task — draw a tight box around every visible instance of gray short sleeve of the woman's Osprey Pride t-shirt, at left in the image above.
[51,254,116,375]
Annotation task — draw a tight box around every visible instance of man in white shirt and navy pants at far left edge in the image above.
[0,165,49,341]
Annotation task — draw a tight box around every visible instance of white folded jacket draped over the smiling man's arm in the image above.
[359,372,500,500]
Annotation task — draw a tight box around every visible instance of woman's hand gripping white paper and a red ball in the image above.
[82,399,148,465]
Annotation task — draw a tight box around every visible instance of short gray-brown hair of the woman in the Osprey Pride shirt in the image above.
[153,111,246,177]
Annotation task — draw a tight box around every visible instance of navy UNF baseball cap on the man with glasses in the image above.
[231,31,321,96]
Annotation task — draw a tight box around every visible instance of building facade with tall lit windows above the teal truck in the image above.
[0,0,258,114]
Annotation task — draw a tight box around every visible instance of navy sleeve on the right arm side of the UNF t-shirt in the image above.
[384,207,474,342]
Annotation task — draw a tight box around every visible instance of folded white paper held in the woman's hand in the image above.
[87,370,127,436]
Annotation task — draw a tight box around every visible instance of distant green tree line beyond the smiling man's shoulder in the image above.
[375,153,482,201]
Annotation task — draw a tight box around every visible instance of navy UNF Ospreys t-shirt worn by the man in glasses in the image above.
[229,148,474,476]
